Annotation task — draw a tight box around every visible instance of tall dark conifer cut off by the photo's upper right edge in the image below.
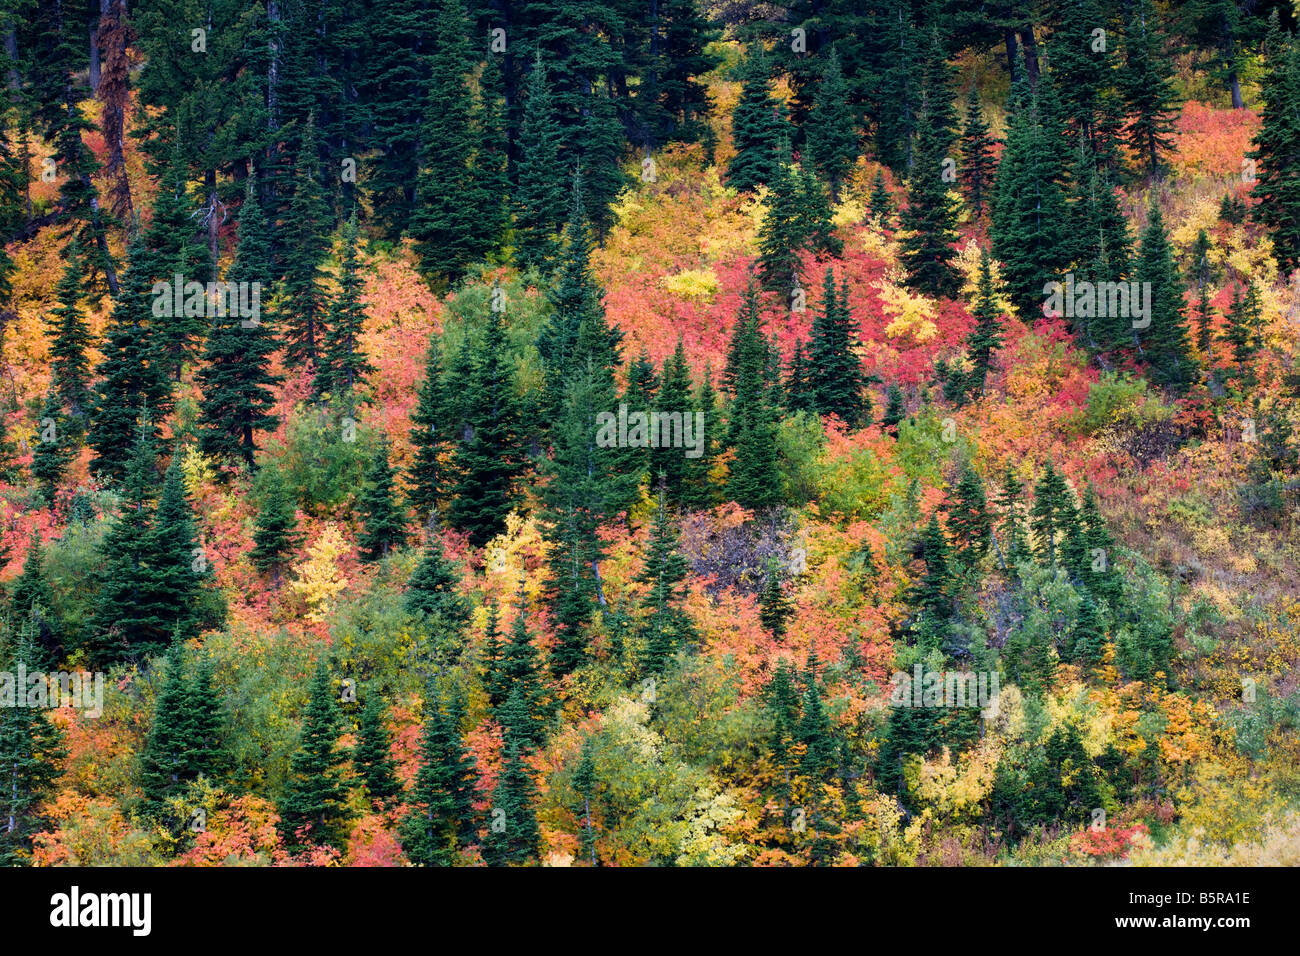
[1248,18,1300,269]
